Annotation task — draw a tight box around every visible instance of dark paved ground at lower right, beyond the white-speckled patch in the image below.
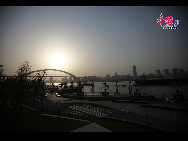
[89,101,188,132]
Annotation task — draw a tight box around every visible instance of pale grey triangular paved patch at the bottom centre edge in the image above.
[71,123,111,132]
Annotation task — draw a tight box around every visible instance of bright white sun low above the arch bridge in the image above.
[50,54,67,69]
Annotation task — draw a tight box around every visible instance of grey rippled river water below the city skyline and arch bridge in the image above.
[47,81,188,99]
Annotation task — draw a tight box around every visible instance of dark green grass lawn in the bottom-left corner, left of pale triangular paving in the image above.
[0,99,89,132]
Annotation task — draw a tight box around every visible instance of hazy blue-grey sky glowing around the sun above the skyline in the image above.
[0,6,188,77]
